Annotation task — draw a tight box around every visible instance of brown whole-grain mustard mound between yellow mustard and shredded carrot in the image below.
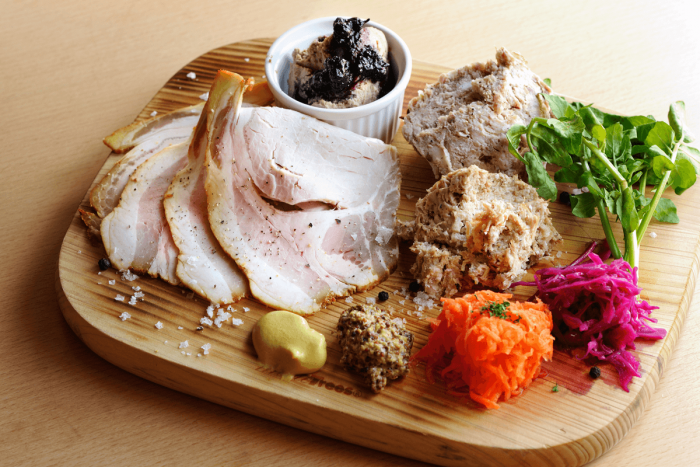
[338,305,413,393]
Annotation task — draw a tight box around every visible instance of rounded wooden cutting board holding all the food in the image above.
[56,39,700,466]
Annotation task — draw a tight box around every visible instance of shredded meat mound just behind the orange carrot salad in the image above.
[398,166,561,298]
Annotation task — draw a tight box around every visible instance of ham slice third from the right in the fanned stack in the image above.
[100,143,188,284]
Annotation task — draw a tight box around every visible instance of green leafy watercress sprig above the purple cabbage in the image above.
[507,94,700,267]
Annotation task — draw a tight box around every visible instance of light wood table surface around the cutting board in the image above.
[0,0,700,467]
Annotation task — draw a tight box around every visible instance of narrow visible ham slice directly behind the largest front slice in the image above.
[163,91,250,304]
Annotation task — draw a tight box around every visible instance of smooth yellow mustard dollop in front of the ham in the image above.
[253,310,326,375]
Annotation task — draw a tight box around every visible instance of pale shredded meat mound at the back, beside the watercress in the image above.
[403,48,551,177]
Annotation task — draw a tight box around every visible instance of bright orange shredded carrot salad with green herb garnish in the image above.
[412,290,554,409]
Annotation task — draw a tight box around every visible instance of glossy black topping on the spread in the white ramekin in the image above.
[294,18,389,104]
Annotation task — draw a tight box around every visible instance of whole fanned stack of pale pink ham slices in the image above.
[83,71,401,314]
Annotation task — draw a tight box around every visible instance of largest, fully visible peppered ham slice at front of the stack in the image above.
[202,71,400,314]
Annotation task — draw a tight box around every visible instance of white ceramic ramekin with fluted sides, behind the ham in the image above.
[265,16,412,143]
